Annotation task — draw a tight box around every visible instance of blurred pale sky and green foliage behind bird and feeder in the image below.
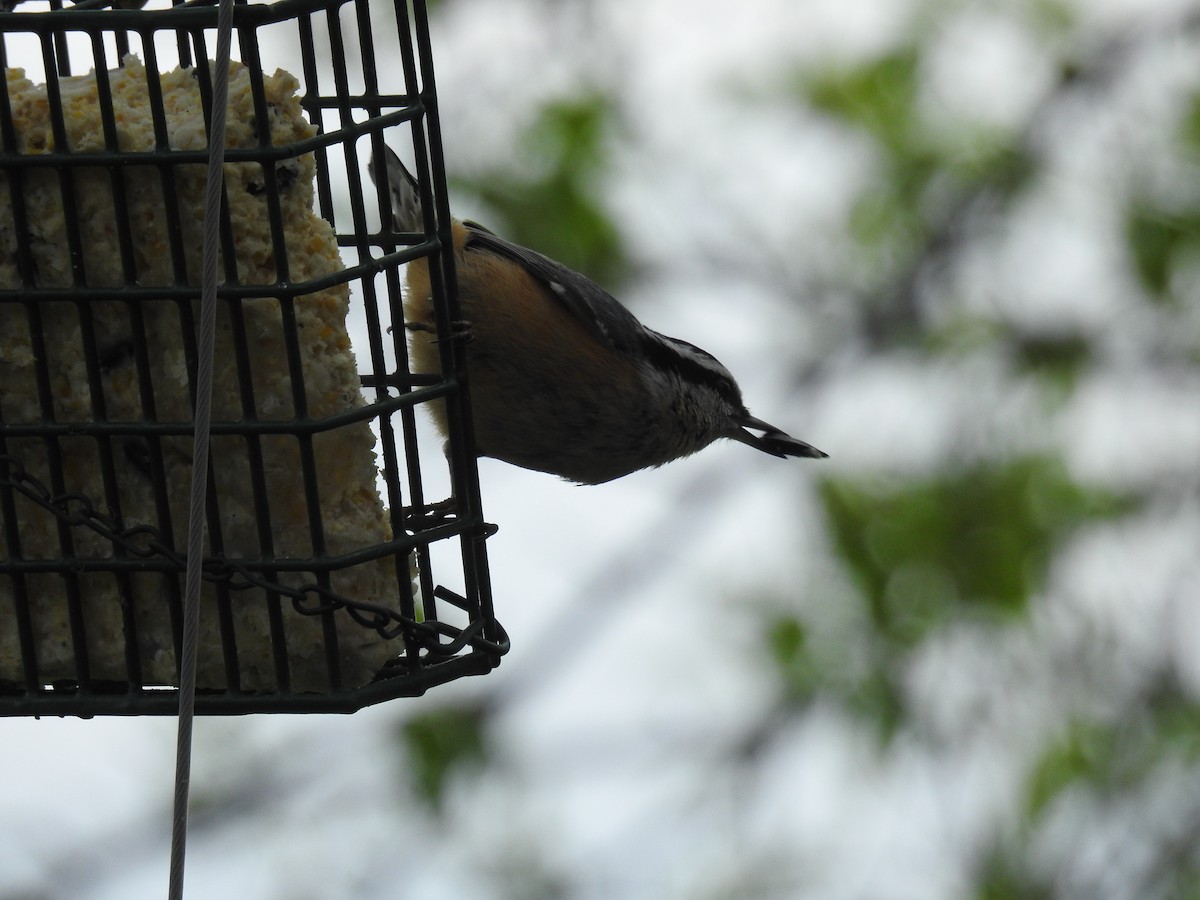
[0,0,1200,900]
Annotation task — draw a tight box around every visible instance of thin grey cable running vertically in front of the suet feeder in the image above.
[168,0,233,900]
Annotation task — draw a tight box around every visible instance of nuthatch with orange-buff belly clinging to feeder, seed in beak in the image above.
[370,149,826,485]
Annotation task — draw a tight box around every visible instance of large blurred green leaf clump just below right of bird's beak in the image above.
[821,456,1128,646]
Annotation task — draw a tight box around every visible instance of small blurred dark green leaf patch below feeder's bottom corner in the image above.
[400,704,487,810]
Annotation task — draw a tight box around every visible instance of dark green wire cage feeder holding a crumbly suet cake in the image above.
[0,0,508,716]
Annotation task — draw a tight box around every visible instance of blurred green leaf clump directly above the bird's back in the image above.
[454,92,629,290]
